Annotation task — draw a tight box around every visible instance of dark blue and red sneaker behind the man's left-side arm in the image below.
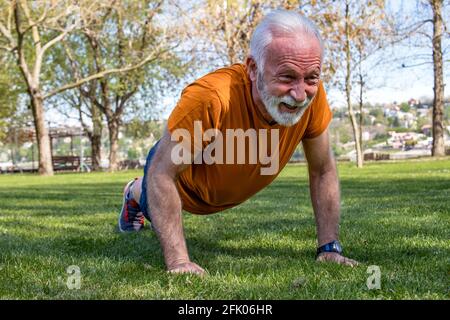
[119,178,145,232]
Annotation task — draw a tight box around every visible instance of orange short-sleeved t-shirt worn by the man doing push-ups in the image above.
[168,64,332,214]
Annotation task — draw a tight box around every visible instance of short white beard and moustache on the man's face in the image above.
[256,72,314,127]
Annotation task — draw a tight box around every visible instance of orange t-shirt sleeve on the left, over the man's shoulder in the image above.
[167,82,222,154]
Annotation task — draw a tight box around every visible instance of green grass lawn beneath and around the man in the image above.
[0,158,450,299]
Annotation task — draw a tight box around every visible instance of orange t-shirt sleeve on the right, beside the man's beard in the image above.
[303,82,333,139]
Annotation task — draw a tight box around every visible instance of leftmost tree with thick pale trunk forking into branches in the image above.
[0,0,106,175]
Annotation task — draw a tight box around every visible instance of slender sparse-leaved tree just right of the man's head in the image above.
[318,0,387,168]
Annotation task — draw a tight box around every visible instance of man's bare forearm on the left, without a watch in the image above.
[147,172,189,270]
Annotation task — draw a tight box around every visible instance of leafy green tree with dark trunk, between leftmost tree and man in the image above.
[58,0,183,171]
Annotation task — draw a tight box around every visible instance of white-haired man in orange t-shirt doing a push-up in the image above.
[119,10,357,274]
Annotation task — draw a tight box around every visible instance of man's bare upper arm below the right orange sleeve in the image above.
[302,129,334,173]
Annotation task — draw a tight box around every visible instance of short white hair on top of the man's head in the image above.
[250,9,324,70]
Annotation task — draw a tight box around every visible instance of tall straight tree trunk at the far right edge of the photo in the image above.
[430,0,445,157]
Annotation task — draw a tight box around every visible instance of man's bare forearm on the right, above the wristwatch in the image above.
[309,163,340,246]
